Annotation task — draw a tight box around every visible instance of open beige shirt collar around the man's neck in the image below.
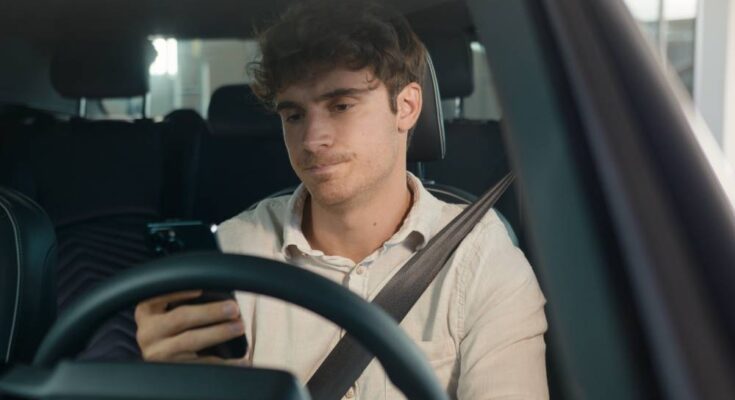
[281,172,444,256]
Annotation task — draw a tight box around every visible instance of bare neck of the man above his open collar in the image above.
[302,173,412,263]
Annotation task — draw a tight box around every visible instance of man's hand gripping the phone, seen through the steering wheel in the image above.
[135,290,246,365]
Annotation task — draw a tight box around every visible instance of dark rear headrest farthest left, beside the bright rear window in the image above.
[51,40,154,98]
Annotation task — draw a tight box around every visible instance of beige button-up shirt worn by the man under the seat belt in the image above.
[217,174,548,400]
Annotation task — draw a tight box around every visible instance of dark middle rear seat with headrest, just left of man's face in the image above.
[193,85,299,223]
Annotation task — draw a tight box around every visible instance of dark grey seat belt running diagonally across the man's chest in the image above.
[306,172,514,400]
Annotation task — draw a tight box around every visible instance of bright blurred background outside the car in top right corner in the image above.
[624,0,735,170]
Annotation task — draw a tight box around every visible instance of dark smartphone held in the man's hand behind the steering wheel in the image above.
[148,220,248,358]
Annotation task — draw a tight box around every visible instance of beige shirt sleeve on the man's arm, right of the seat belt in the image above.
[457,213,549,400]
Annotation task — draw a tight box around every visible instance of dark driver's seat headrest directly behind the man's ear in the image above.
[406,56,446,162]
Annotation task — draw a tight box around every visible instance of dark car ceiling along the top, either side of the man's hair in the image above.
[0,0,472,42]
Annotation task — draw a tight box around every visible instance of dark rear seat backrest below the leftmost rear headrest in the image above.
[0,119,164,359]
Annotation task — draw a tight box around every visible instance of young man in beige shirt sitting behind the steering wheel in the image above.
[136,0,548,399]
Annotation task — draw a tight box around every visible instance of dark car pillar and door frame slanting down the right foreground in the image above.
[468,0,735,399]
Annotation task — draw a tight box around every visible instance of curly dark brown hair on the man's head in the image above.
[248,0,426,113]
